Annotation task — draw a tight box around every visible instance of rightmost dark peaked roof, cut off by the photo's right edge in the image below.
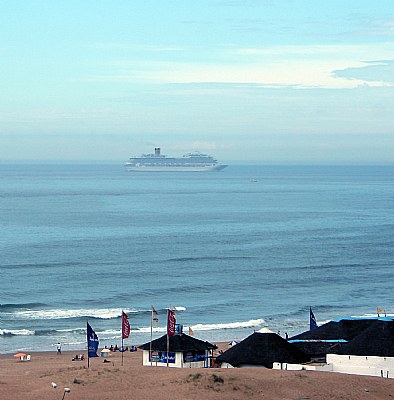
[340,321,394,357]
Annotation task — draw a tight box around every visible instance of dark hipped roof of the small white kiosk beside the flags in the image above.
[139,333,217,352]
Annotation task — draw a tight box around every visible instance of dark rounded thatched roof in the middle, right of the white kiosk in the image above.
[216,332,309,368]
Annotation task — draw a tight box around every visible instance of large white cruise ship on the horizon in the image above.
[126,147,227,172]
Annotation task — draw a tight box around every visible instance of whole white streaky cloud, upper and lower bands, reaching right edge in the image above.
[85,43,394,89]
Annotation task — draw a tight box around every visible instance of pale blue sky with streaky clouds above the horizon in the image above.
[0,0,394,164]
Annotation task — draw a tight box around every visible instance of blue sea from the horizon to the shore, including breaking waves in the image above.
[0,164,394,353]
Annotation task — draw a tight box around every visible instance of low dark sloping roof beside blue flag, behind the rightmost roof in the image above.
[289,319,376,341]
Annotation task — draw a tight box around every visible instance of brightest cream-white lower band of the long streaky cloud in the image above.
[90,60,391,89]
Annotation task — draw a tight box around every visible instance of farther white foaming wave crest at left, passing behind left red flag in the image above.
[13,308,142,320]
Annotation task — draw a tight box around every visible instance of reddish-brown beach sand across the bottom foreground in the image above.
[0,351,394,400]
